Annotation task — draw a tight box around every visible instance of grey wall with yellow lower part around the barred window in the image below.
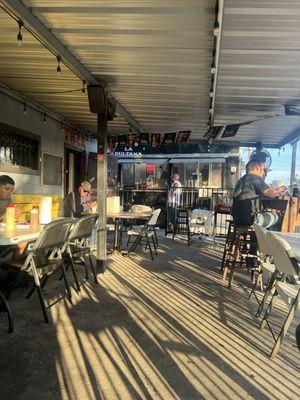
[0,93,64,196]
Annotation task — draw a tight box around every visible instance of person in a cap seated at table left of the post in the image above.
[64,181,96,218]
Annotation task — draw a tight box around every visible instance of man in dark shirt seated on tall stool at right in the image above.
[232,153,286,226]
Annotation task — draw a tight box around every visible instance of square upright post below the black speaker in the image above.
[97,114,107,273]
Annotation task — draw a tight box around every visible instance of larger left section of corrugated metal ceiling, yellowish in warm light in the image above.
[0,0,215,139]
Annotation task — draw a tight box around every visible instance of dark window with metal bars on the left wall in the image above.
[0,127,39,170]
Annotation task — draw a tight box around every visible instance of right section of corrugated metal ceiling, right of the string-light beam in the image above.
[214,0,300,144]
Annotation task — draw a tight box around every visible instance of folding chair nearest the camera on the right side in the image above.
[260,232,300,358]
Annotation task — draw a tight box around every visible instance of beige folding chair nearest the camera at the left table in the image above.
[2,219,74,322]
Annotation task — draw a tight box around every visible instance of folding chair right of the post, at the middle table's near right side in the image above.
[122,208,161,261]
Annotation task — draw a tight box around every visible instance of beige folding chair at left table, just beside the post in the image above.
[64,214,98,291]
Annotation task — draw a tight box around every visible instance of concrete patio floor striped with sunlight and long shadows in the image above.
[0,234,300,400]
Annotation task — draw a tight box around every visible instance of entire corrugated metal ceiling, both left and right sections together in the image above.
[0,0,300,145]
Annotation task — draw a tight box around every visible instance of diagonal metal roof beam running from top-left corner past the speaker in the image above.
[1,0,145,132]
